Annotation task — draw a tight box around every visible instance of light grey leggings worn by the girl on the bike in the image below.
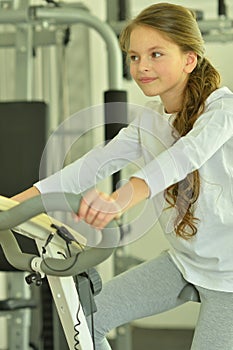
[91,252,233,350]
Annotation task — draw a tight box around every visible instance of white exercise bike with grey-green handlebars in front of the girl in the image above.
[0,193,120,350]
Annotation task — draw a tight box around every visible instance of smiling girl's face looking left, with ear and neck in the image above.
[128,26,197,113]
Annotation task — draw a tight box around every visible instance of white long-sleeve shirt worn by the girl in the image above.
[35,87,233,292]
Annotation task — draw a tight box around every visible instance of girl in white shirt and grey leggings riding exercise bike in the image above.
[15,3,233,350]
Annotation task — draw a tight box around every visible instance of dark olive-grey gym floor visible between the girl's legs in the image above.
[111,327,193,350]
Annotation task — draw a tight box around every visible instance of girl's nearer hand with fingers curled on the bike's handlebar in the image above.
[77,189,121,229]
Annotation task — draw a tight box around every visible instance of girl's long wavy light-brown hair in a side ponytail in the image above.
[120,3,220,239]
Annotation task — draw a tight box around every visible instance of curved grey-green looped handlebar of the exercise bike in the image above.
[0,193,120,276]
